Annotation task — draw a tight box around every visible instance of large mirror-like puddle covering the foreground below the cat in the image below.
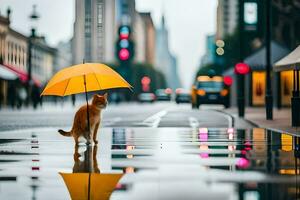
[0,127,300,200]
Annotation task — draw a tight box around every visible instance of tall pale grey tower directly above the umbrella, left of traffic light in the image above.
[72,0,117,64]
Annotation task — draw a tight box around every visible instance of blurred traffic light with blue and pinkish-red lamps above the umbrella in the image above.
[116,25,134,64]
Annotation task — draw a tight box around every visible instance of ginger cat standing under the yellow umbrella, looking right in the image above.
[58,93,107,146]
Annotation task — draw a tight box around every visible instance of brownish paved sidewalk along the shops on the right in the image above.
[225,107,300,136]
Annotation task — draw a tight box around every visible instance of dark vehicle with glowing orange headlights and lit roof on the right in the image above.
[192,76,230,108]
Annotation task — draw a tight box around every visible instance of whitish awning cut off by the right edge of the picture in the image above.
[273,45,300,71]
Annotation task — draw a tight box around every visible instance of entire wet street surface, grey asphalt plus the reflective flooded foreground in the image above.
[0,102,299,199]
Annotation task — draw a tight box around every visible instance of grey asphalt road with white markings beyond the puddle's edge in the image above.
[0,102,232,131]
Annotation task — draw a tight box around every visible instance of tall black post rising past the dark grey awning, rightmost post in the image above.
[265,0,273,120]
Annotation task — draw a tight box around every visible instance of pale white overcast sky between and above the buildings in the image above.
[0,0,217,88]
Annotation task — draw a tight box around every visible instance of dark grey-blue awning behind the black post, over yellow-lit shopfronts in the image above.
[244,41,289,70]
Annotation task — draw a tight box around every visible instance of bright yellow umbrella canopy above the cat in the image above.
[41,63,132,96]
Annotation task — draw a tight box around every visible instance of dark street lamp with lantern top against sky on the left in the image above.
[26,5,40,105]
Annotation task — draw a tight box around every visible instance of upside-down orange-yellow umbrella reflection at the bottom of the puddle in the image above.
[60,173,123,200]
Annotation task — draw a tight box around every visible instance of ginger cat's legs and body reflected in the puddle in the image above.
[73,145,100,173]
